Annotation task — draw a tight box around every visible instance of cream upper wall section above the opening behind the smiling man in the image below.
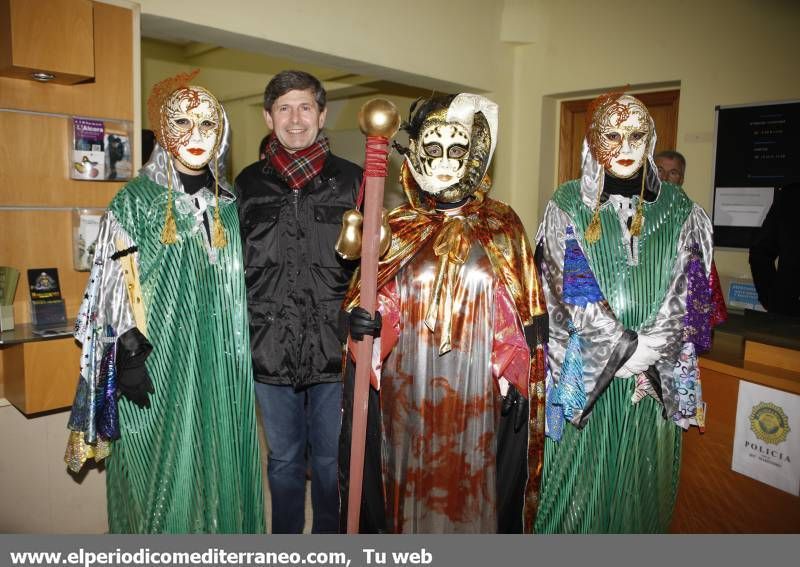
[140,0,503,90]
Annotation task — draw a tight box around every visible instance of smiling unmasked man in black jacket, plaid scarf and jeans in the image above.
[236,71,362,533]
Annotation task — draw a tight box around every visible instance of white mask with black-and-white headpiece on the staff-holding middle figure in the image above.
[406,93,497,203]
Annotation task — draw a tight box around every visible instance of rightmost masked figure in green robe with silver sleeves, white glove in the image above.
[536,93,724,533]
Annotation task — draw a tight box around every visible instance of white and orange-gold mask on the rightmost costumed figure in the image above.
[589,95,654,179]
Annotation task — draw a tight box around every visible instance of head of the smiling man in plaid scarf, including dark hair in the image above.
[264,71,327,153]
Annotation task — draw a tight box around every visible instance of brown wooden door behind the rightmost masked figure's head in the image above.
[558,90,680,184]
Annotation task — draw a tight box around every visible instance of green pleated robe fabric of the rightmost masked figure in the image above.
[536,180,693,533]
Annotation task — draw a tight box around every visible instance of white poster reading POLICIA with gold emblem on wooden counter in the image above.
[731,380,800,496]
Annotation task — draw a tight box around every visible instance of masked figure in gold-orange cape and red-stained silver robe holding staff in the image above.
[340,94,546,533]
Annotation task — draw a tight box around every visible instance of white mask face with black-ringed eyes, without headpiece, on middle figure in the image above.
[416,123,470,195]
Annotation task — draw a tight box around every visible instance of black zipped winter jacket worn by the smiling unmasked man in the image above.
[236,155,362,389]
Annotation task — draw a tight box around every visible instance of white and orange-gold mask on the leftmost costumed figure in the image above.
[161,86,222,170]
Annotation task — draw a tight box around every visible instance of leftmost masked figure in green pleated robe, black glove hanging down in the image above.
[65,74,264,533]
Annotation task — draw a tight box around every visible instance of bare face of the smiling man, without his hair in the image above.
[264,89,327,153]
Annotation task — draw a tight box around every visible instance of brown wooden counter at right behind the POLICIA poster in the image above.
[671,314,800,533]
